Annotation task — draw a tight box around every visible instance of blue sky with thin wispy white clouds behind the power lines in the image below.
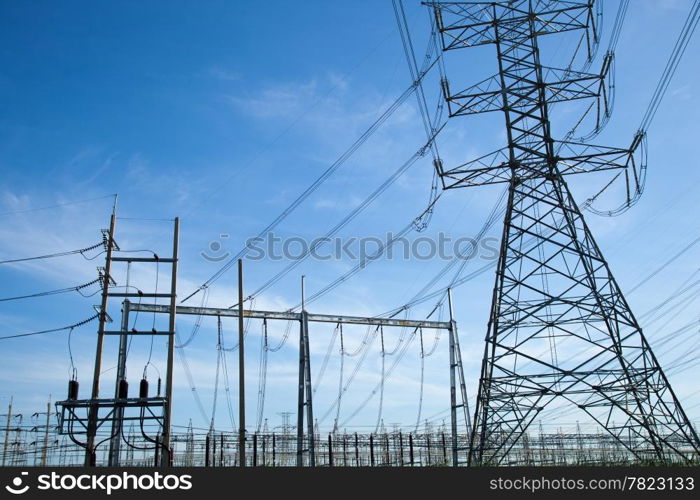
[0,0,700,438]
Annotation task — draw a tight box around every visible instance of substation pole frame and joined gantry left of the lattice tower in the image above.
[56,210,470,467]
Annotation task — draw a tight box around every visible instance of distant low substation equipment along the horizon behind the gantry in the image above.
[6,402,691,467]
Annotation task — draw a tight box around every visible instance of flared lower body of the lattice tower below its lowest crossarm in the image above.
[472,174,699,464]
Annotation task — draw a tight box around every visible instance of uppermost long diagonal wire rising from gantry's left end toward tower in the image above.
[182,49,442,303]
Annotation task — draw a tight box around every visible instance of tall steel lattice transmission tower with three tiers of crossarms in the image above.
[428,0,700,464]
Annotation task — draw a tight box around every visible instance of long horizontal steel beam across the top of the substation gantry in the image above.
[129,303,450,330]
